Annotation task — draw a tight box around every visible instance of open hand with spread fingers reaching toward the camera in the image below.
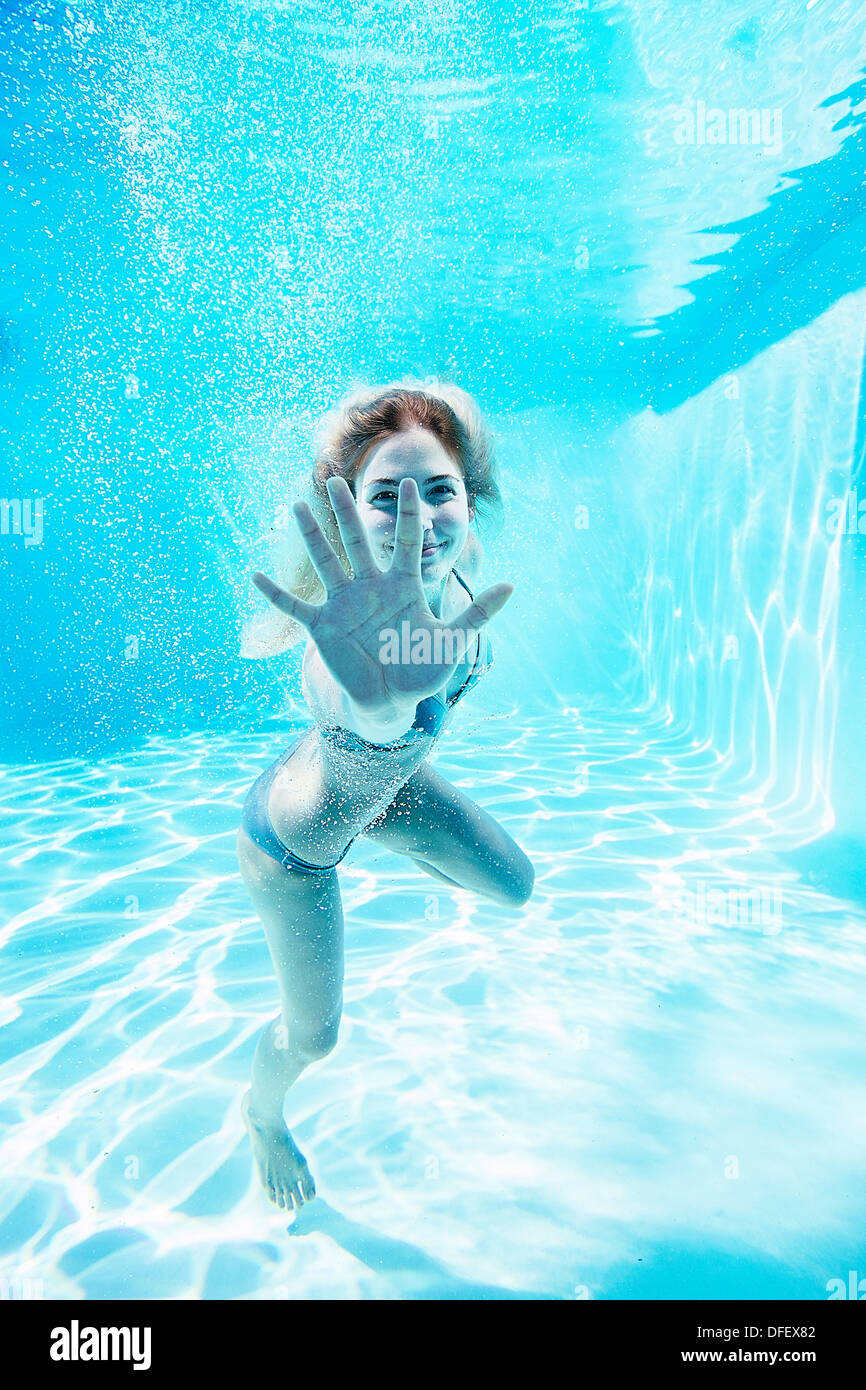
[253,478,514,716]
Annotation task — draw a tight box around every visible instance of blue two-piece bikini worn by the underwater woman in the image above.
[240,570,493,873]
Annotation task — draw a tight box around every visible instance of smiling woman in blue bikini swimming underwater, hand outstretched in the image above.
[238,382,534,1209]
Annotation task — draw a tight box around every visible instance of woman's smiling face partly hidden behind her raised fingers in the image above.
[354,425,473,585]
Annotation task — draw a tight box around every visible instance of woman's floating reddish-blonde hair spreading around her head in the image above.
[240,378,502,656]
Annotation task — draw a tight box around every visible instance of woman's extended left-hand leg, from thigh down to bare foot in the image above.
[238,830,343,1211]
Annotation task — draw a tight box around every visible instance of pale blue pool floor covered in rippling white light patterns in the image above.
[0,716,866,1298]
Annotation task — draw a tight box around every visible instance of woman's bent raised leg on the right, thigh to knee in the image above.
[364,763,535,908]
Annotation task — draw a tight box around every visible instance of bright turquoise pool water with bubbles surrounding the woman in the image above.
[0,3,866,1300]
